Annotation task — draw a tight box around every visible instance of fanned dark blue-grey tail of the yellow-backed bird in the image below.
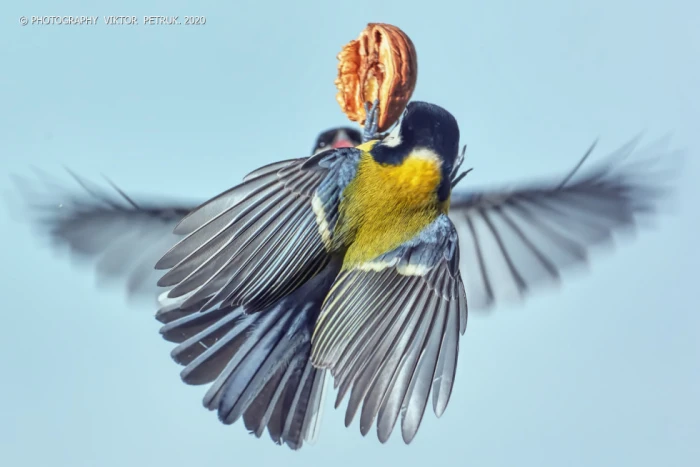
[157,259,340,449]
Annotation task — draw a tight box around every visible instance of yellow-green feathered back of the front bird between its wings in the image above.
[334,146,448,269]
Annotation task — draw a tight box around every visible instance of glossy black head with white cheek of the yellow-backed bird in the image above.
[372,101,459,174]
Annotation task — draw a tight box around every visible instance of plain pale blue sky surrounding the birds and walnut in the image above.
[0,0,700,467]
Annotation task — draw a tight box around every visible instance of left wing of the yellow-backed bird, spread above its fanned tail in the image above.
[156,148,360,312]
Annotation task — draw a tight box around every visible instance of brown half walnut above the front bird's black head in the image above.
[335,23,418,132]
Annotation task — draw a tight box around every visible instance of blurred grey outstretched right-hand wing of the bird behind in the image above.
[449,140,677,310]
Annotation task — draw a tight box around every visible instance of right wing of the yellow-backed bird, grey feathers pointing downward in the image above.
[311,215,467,443]
